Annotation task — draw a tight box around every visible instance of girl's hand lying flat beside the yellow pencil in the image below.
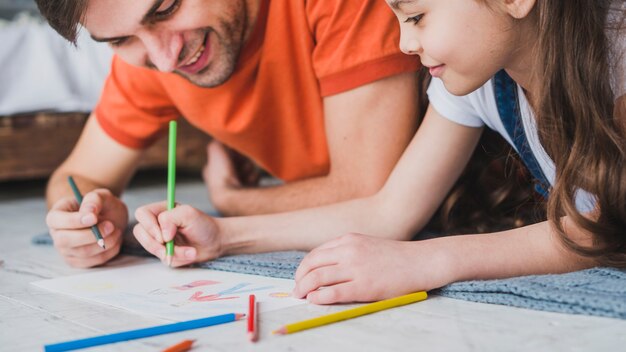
[294,234,451,304]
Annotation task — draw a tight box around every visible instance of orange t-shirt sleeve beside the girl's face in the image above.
[306,0,420,96]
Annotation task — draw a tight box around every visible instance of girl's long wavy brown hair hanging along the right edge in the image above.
[534,0,626,267]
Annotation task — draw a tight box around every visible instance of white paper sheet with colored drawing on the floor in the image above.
[32,263,306,321]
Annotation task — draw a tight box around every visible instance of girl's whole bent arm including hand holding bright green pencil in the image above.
[135,108,481,265]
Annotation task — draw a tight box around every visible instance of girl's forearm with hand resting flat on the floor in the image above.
[294,219,595,304]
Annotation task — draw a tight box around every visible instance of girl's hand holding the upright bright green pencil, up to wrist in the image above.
[133,202,222,267]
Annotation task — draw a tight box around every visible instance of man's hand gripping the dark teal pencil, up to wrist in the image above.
[46,189,128,268]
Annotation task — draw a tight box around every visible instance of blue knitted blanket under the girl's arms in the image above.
[33,234,626,319]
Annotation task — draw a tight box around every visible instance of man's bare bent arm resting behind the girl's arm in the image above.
[209,73,418,216]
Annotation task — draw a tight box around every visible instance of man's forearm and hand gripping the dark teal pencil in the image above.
[46,114,142,267]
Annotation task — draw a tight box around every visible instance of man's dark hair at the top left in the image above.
[35,0,87,44]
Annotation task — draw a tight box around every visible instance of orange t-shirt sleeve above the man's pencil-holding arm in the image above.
[95,56,179,149]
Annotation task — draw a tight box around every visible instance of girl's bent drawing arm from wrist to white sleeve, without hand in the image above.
[215,104,482,254]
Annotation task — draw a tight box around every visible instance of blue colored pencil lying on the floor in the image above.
[44,313,245,352]
